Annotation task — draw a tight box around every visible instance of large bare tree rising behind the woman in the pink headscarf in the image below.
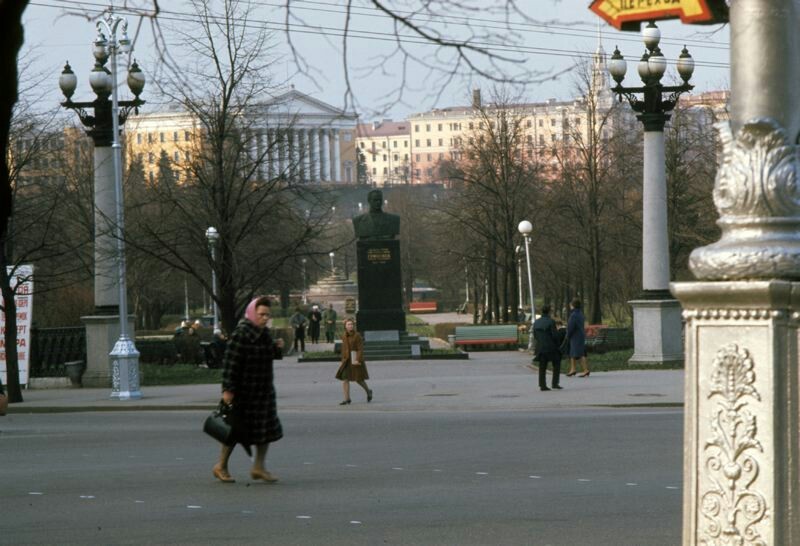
[121,0,327,331]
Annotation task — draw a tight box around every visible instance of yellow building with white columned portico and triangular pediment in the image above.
[126,88,358,184]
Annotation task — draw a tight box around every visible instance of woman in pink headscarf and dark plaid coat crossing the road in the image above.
[213,296,283,483]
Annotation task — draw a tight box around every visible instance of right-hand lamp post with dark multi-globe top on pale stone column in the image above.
[608,22,694,365]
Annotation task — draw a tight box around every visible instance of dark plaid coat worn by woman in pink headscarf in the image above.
[222,319,283,445]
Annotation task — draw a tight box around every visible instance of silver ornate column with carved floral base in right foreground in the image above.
[672,0,800,546]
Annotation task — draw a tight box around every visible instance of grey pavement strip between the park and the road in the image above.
[9,347,683,414]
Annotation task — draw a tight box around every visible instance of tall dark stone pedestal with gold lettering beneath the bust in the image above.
[356,239,406,333]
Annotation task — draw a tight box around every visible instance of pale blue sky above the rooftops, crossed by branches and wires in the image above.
[23,0,729,121]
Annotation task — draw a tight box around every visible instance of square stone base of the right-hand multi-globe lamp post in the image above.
[628,298,683,367]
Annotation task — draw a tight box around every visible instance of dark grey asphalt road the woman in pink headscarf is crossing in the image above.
[0,406,683,546]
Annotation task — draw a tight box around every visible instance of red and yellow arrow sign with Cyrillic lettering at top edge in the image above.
[589,0,727,29]
